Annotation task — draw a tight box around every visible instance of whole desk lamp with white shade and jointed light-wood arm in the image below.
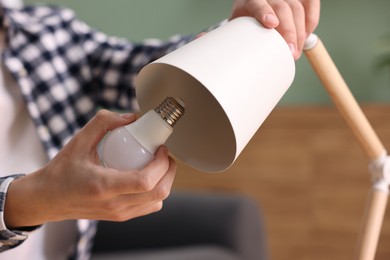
[136,17,390,260]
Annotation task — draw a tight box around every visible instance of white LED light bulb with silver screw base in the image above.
[100,97,184,170]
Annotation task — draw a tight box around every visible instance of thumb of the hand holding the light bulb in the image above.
[76,109,135,149]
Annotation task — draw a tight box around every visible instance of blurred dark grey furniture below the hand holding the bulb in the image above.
[92,192,267,260]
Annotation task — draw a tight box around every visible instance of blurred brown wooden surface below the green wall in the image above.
[174,105,390,260]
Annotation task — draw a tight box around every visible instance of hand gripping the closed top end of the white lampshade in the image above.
[230,0,320,60]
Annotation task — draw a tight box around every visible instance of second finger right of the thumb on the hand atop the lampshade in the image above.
[286,0,306,59]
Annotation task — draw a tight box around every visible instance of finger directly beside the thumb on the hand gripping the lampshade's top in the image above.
[272,1,297,58]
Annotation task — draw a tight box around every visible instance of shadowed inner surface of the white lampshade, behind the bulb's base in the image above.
[137,63,236,172]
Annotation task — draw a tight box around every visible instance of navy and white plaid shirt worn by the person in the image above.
[0,6,192,259]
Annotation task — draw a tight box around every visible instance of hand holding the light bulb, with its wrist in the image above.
[5,110,176,228]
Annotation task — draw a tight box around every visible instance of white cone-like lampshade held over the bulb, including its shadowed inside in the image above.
[136,17,295,172]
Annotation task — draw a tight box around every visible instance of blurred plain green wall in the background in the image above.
[24,0,390,105]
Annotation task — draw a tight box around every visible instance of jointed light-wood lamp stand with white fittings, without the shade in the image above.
[304,34,390,260]
